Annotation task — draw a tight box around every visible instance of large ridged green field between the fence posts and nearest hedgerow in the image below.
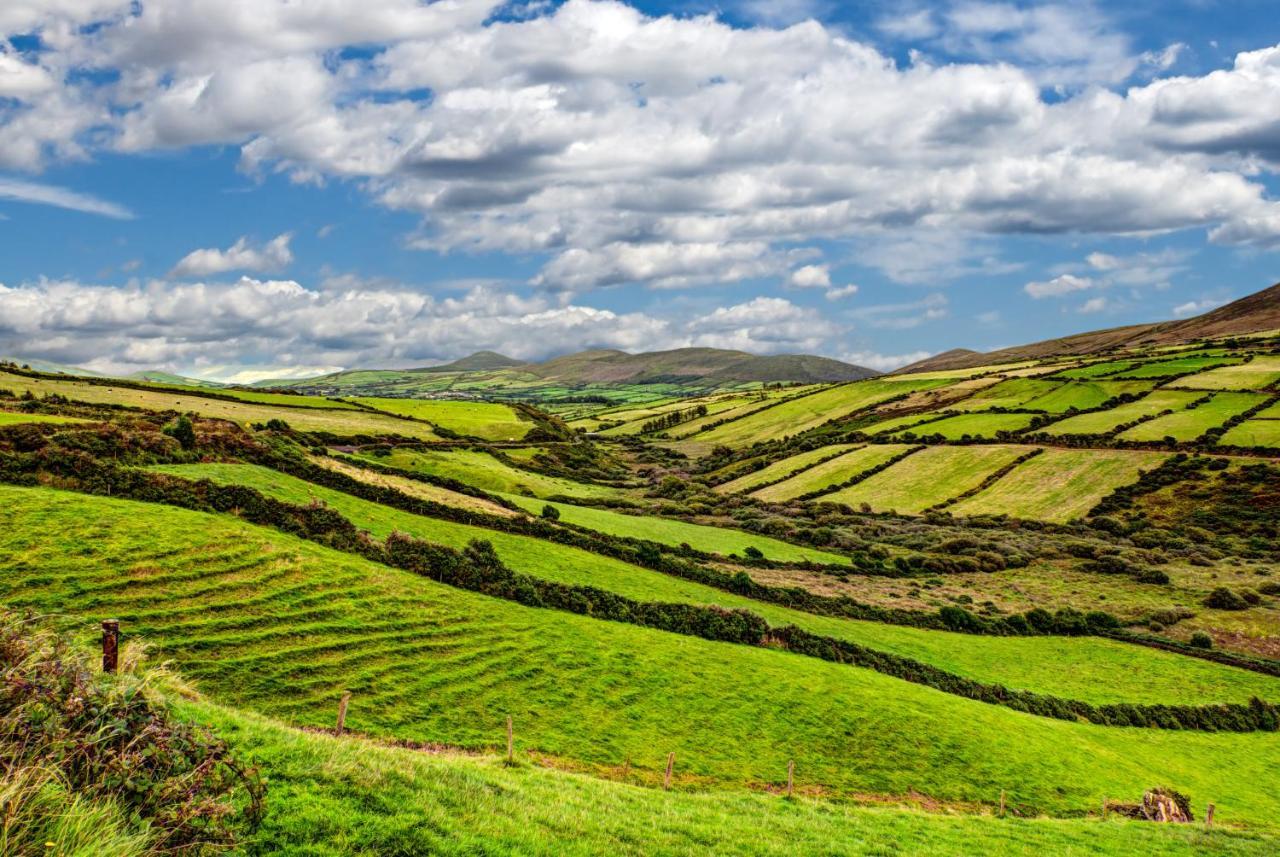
[0,487,1280,828]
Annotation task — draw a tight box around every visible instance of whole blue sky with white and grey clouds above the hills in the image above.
[0,0,1280,380]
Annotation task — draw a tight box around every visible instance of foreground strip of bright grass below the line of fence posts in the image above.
[186,702,1280,857]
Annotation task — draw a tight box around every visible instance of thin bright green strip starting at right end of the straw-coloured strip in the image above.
[506,494,849,565]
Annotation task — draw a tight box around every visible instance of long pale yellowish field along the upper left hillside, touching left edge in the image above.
[0,372,436,440]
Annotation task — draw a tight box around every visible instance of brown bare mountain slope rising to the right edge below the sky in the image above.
[895,284,1280,375]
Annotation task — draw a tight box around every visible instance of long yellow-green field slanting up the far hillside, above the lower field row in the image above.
[680,377,947,446]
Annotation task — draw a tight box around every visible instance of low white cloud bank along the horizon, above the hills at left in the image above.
[0,276,842,377]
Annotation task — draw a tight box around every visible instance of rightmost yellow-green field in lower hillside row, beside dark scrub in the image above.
[950,449,1167,523]
